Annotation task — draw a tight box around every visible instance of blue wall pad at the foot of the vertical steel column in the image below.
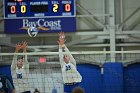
[103,63,123,93]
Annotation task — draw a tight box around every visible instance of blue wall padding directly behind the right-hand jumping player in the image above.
[64,64,102,93]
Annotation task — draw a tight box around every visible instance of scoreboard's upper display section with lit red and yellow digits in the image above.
[4,0,76,19]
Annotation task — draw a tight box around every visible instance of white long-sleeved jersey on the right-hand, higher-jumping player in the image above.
[59,46,82,83]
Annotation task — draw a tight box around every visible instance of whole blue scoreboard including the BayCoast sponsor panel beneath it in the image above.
[3,0,76,34]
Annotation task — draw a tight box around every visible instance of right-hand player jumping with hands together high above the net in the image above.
[58,32,82,85]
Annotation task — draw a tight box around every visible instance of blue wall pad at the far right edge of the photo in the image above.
[124,64,140,93]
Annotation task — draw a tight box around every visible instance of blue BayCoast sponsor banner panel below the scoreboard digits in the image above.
[4,17,76,34]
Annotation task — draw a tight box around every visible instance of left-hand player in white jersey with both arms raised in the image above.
[11,42,31,93]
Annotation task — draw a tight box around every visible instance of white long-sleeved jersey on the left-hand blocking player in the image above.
[11,55,29,93]
